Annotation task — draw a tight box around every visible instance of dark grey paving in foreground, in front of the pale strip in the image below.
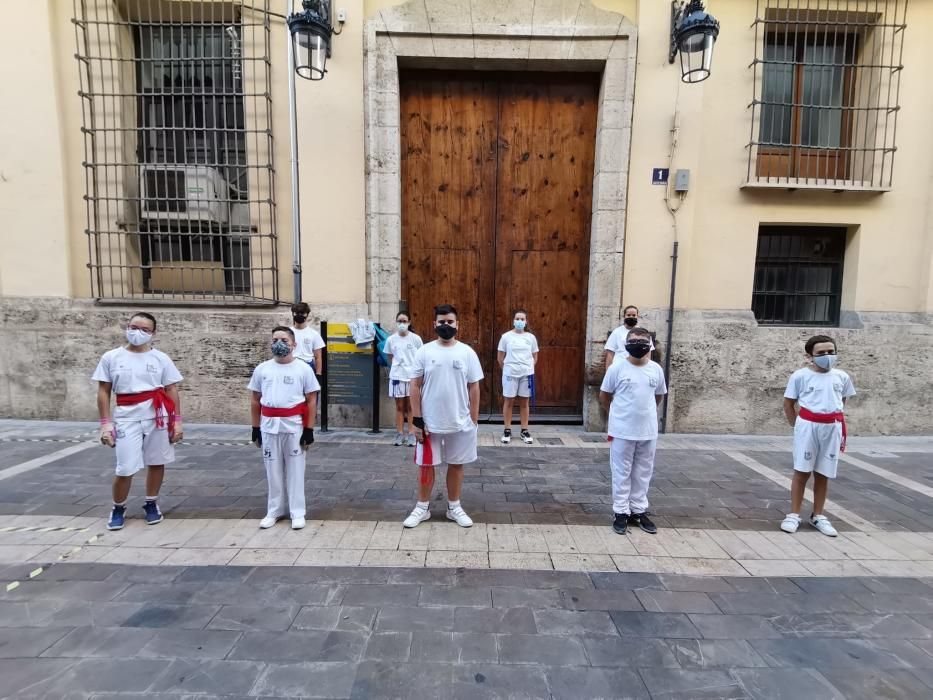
[0,563,933,700]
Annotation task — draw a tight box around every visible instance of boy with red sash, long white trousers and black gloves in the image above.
[248,326,321,530]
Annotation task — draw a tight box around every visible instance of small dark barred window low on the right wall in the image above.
[752,226,846,326]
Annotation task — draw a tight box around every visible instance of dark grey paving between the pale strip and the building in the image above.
[0,421,933,532]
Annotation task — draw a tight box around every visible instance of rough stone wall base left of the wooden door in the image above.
[0,297,370,427]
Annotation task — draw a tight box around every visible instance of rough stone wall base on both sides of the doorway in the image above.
[0,297,933,435]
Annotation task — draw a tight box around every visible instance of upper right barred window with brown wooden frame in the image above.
[747,0,907,191]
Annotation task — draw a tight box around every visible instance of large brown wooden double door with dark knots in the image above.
[400,71,599,415]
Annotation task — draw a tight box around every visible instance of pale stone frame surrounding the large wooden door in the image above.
[363,0,637,427]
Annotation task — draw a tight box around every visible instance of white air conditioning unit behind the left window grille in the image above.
[139,163,230,225]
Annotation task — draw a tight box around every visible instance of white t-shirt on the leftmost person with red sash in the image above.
[91,347,183,420]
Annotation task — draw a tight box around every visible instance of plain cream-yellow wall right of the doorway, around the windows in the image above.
[623,0,933,312]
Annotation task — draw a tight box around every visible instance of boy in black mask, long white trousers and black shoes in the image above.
[599,327,667,535]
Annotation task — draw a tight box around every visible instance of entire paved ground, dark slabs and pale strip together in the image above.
[0,421,933,700]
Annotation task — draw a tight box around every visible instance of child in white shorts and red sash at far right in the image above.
[781,335,855,537]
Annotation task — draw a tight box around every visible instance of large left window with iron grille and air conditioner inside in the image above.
[73,0,278,305]
